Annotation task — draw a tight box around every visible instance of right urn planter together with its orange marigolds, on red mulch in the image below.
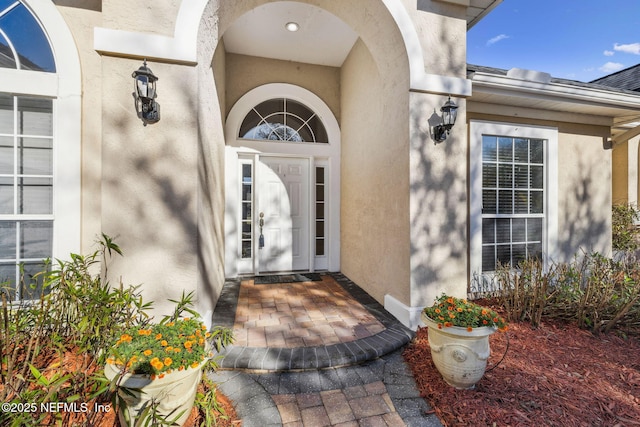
[422,294,507,389]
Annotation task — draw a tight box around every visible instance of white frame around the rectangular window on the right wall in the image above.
[469,120,558,287]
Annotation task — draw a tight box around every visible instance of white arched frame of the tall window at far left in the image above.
[0,0,82,298]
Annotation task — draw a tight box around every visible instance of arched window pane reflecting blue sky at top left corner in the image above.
[0,0,56,73]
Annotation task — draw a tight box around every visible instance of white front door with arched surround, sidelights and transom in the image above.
[225,83,340,277]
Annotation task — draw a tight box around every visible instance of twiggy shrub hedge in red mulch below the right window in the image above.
[495,253,640,333]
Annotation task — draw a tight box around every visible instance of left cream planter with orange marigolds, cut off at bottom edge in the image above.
[104,295,232,426]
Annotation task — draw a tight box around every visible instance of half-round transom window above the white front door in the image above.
[238,98,329,143]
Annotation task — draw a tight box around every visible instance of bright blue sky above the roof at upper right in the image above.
[467,0,640,82]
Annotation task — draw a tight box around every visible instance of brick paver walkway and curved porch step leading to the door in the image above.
[210,273,441,427]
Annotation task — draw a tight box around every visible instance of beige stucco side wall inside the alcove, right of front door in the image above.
[341,36,409,301]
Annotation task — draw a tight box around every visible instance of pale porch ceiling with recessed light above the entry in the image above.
[223,1,358,67]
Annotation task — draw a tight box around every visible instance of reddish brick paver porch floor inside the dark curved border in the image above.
[233,276,385,348]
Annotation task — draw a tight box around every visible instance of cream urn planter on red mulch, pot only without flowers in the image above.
[422,312,497,389]
